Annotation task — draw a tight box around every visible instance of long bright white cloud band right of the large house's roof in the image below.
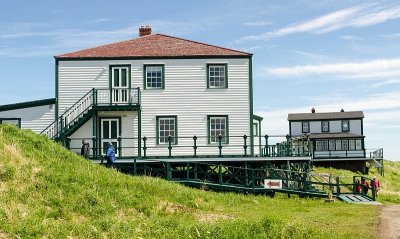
[262,58,400,80]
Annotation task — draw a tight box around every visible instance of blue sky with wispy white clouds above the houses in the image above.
[0,0,400,160]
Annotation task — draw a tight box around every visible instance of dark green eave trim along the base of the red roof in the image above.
[54,54,253,61]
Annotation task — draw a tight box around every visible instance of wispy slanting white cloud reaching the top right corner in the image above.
[239,3,400,42]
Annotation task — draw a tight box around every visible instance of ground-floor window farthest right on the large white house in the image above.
[207,115,229,144]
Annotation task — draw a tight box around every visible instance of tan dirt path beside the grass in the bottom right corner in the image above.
[377,205,400,239]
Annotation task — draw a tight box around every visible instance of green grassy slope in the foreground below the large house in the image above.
[0,126,378,238]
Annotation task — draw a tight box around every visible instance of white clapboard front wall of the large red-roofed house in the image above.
[58,58,250,156]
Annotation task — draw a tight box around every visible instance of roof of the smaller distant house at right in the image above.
[288,111,364,121]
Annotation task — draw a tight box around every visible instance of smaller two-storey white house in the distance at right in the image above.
[288,108,367,172]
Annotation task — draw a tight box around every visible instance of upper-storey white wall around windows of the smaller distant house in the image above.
[290,119,362,136]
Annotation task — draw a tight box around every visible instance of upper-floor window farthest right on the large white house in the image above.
[207,64,228,88]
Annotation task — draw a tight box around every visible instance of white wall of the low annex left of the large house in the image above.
[0,104,54,133]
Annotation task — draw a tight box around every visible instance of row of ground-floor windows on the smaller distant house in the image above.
[315,139,363,151]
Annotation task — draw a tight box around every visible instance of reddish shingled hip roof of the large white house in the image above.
[55,34,252,59]
